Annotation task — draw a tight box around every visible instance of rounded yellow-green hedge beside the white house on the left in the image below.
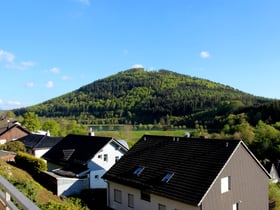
[15,152,47,176]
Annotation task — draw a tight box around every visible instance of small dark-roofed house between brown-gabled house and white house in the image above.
[17,134,62,158]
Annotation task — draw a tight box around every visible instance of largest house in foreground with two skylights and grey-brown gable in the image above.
[102,135,269,210]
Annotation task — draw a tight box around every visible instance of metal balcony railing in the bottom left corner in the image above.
[0,176,39,210]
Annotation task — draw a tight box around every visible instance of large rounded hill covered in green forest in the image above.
[15,68,269,123]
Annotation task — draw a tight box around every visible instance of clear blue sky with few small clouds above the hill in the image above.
[0,0,280,109]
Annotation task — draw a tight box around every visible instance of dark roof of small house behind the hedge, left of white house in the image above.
[17,134,62,149]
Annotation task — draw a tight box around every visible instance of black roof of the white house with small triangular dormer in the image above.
[43,134,112,165]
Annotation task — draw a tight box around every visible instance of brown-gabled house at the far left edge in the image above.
[0,119,31,144]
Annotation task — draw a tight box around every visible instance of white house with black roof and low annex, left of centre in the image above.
[42,134,128,196]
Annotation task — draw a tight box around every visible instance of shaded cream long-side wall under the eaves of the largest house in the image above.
[107,182,200,210]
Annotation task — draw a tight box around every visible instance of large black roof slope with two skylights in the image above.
[103,135,241,205]
